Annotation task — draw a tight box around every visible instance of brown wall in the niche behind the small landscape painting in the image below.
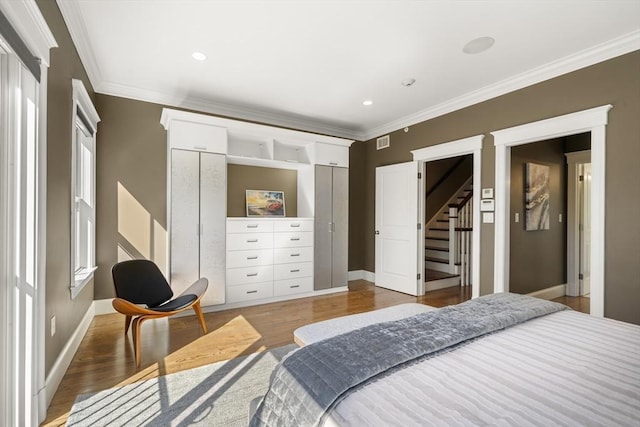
[227,165,298,217]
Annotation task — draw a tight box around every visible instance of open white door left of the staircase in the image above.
[375,162,421,295]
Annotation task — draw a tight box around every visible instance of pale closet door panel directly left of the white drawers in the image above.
[200,153,227,306]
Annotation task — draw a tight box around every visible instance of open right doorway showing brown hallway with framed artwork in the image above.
[509,133,591,305]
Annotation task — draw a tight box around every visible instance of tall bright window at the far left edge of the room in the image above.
[0,37,43,425]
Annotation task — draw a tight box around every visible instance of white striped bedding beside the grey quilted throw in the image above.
[325,311,640,427]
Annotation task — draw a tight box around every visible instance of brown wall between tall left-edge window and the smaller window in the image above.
[37,0,95,375]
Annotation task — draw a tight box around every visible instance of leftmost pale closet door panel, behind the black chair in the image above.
[170,150,200,294]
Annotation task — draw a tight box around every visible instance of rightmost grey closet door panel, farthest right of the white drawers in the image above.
[331,168,349,288]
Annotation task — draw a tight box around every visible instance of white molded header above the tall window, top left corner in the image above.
[0,0,58,67]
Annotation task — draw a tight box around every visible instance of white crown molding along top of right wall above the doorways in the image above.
[364,30,640,141]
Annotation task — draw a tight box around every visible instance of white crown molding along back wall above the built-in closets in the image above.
[94,82,363,141]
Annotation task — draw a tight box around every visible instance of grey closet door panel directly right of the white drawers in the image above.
[313,165,332,290]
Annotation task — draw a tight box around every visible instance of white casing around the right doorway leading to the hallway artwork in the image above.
[491,105,612,317]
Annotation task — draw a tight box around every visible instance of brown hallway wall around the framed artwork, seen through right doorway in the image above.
[509,139,567,294]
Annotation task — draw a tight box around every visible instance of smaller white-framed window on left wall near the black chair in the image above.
[70,79,100,298]
